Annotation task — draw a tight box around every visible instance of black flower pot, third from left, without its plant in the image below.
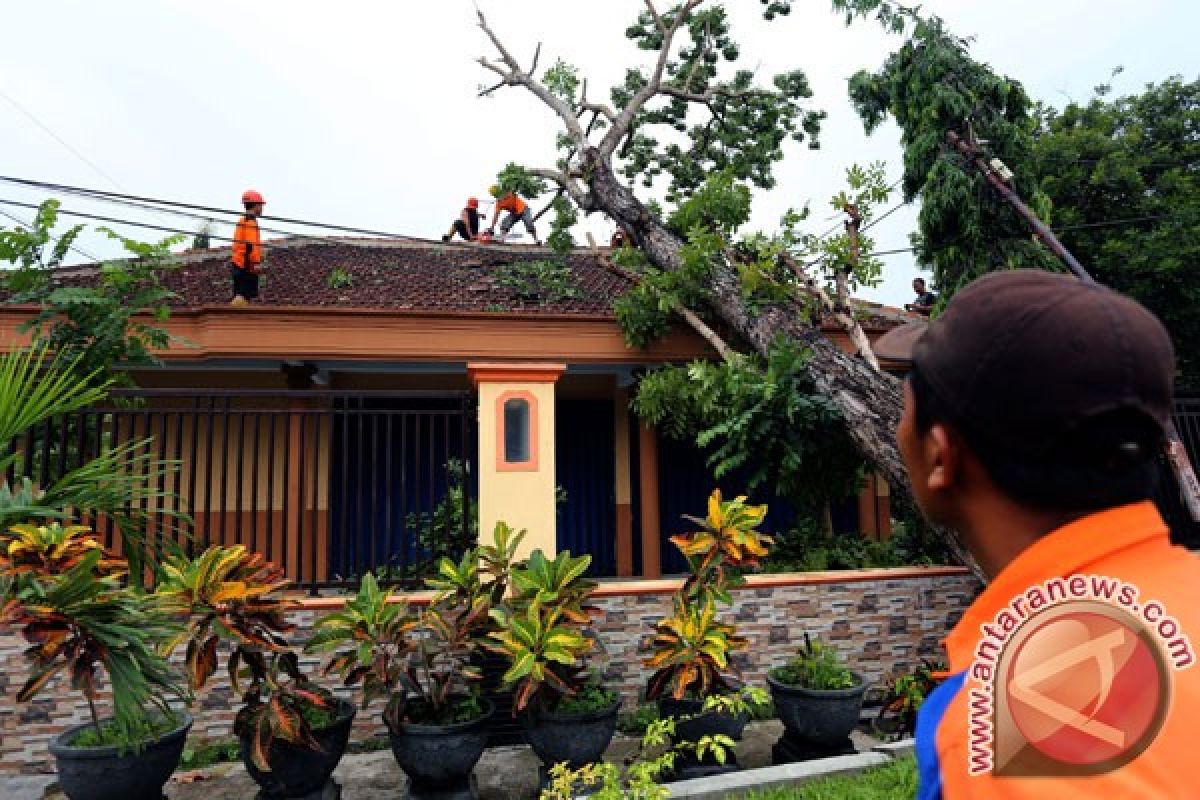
[388,697,496,796]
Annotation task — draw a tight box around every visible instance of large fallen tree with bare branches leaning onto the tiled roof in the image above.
[479,0,978,573]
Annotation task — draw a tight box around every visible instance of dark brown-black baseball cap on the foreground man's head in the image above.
[876,270,1175,452]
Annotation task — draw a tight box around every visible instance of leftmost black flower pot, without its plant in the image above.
[50,711,192,800]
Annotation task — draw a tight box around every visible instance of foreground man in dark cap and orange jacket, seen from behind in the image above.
[876,270,1200,800]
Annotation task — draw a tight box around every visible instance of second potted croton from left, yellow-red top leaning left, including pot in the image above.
[156,545,355,798]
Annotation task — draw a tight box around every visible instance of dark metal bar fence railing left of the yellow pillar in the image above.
[6,390,474,590]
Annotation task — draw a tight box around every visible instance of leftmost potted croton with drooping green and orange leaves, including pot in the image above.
[0,523,192,800]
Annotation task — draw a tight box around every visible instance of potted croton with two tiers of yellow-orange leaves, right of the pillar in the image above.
[644,489,772,762]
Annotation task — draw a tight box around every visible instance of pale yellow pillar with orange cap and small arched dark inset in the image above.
[467,363,566,557]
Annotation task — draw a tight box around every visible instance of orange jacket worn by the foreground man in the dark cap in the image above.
[918,501,1200,800]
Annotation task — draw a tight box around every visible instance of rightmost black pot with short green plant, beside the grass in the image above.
[767,633,866,747]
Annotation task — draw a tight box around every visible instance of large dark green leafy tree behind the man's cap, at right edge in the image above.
[1032,77,1200,390]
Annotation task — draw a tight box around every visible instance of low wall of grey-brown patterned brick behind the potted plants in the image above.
[0,575,978,775]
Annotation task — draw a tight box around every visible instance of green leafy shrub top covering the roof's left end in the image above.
[0,200,184,384]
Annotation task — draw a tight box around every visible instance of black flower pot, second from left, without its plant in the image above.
[241,700,355,798]
